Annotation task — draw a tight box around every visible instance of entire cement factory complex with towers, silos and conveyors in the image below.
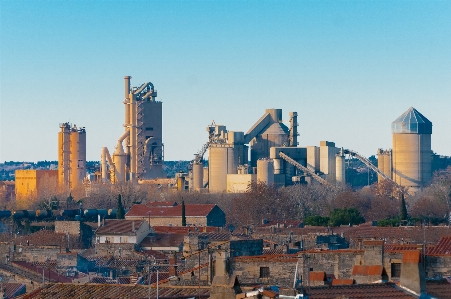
[12,76,441,198]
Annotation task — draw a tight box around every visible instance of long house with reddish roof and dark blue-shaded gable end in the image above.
[125,202,226,227]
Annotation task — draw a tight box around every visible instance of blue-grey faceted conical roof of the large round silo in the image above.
[391,107,432,134]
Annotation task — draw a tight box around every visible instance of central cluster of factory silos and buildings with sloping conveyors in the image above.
[190,109,345,193]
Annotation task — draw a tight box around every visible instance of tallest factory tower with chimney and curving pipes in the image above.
[101,76,165,183]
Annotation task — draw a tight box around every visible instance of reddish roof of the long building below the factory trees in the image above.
[125,204,216,218]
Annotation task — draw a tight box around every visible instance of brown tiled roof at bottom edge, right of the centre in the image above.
[310,283,416,299]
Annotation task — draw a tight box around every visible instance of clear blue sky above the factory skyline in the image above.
[0,0,451,162]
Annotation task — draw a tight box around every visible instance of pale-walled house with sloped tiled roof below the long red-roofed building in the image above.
[95,219,153,244]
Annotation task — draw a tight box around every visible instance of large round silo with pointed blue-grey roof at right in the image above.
[392,107,432,193]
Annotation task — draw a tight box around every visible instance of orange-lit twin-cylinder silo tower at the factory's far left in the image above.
[58,123,86,190]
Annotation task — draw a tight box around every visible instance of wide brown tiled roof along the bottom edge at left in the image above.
[18,284,210,299]
